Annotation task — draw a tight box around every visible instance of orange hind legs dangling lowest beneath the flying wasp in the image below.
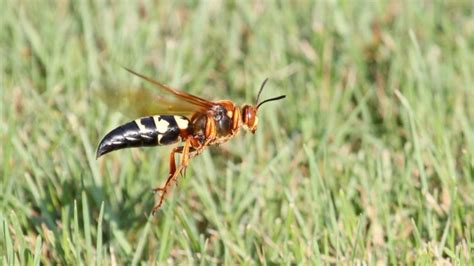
[151,138,194,215]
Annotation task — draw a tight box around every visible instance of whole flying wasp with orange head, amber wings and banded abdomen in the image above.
[97,68,286,214]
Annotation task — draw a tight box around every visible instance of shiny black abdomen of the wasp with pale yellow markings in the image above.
[97,115,192,158]
